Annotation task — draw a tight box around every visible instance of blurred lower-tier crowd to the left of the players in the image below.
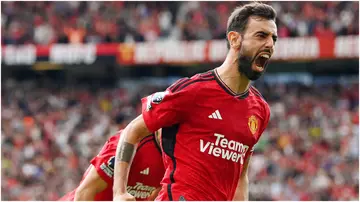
[1,77,157,200]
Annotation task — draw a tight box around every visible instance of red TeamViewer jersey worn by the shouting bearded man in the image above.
[142,70,270,201]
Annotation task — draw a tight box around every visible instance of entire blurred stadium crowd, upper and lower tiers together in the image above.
[1,2,359,200]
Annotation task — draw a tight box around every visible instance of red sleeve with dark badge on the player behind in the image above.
[90,135,119,184]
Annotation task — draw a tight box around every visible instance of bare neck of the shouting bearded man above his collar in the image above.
[217,50,250,94]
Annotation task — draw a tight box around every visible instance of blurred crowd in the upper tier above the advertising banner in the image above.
[1,1,359,45]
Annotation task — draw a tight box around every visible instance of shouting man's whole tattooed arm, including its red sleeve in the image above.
[113,81,195,200]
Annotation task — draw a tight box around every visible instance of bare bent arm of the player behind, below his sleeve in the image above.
[74,165,108,201]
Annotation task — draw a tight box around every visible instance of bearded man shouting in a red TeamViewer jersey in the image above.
[114,3,277,201]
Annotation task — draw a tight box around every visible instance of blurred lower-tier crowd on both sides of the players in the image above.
[1,79,359,201]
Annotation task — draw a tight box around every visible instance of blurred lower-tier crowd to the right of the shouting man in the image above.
[249,83,359,201]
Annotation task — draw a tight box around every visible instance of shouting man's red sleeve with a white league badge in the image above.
[141,78,195,132]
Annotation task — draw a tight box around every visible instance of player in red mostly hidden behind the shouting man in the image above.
[59,131,165,201]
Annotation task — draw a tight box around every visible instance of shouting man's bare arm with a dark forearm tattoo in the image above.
[113,115,151,201]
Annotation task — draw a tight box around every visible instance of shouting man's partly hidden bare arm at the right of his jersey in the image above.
[233,155,251,201]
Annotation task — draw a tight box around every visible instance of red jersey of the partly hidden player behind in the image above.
[59,131,165,201]
